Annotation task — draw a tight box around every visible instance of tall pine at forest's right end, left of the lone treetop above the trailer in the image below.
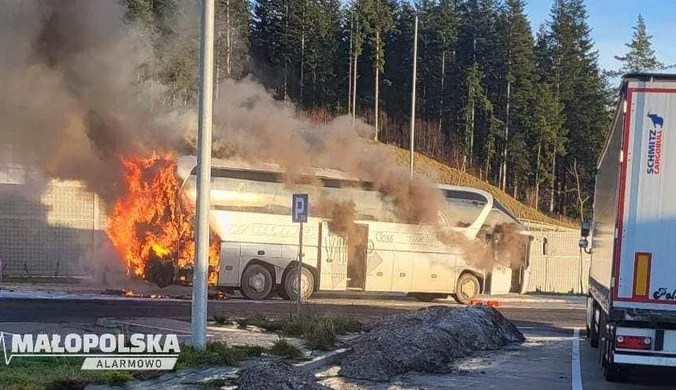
[539,0,609,213]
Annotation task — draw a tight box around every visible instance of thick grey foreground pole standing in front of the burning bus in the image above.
[191,0,214,350]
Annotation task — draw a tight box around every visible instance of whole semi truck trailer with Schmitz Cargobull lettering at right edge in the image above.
[580,73,676,382]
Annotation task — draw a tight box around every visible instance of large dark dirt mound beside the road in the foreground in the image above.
[340,307,525,382]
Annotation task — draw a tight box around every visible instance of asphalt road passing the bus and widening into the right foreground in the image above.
[0,296,676,390]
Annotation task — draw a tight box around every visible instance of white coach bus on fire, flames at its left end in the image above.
[109,156,530,303]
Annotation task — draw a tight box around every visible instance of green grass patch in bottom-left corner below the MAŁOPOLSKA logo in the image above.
[0,357,134,390]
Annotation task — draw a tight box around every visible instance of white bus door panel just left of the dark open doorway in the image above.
[319,222,348,291]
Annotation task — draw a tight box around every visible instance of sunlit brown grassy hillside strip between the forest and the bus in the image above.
[387,145,577,228]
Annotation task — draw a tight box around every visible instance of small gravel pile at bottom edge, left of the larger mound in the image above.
[239,360,328,390]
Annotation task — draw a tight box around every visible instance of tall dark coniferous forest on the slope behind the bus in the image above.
[122,0,662,218]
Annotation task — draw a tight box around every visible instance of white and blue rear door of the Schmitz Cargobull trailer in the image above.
[613,81,676,310]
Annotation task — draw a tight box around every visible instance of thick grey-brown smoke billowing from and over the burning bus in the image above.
[0,0,528,274]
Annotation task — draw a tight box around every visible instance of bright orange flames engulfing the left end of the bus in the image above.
[106,153,220,284]
